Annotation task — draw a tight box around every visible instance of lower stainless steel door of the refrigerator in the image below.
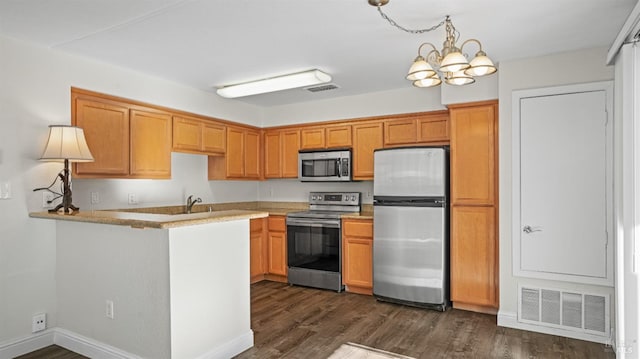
[373,206,449,305]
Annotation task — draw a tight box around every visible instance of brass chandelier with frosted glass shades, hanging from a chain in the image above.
[368,0,497,87]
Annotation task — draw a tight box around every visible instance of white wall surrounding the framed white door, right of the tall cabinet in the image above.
[498,48,614,340]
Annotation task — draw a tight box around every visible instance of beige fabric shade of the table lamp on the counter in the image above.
[40,125,93,162]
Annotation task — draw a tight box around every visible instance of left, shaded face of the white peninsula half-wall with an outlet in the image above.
[55,221,171,358]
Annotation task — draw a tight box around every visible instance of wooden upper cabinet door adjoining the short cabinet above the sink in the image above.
[130,110,172,178]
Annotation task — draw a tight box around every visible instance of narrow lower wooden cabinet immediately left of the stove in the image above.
[267,216,287,282]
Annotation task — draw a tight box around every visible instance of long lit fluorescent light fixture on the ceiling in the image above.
[216,69,331,98]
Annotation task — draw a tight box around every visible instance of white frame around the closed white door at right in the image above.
[511,81,614,287]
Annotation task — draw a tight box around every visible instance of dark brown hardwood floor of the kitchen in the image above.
[20,281,615,359]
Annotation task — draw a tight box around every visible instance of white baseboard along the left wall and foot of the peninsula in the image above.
[0,328,253,359]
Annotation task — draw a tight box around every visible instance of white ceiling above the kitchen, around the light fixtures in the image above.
[0,0,637,106]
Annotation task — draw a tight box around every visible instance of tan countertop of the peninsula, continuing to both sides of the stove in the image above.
[29,202,373,228]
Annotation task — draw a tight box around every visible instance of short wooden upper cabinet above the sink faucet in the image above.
[173,116,226,155]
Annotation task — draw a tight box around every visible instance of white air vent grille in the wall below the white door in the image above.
[518,286,611,337]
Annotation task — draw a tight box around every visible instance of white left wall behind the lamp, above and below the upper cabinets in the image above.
[0,37,262,351]
